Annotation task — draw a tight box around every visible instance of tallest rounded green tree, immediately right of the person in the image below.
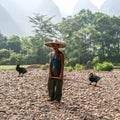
[58,10,95,66]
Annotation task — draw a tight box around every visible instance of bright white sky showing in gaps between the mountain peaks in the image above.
[53,0,105,15]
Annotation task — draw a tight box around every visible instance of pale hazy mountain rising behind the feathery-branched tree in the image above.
[0,0,62,36]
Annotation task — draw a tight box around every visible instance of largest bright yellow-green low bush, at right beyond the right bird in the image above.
[94,62,114,71]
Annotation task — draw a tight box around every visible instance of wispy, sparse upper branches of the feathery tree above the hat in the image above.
[29,14,57,40]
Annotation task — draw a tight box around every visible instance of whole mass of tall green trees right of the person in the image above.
[58,10,120,65]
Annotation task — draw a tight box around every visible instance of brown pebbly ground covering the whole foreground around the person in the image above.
[0,68,120,120]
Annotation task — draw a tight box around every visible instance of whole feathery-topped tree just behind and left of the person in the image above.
[29,14,61,64]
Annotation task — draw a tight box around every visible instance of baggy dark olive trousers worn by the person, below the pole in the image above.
[48,78,63,102]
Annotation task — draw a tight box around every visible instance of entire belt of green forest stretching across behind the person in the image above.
[0,10,120,66]
